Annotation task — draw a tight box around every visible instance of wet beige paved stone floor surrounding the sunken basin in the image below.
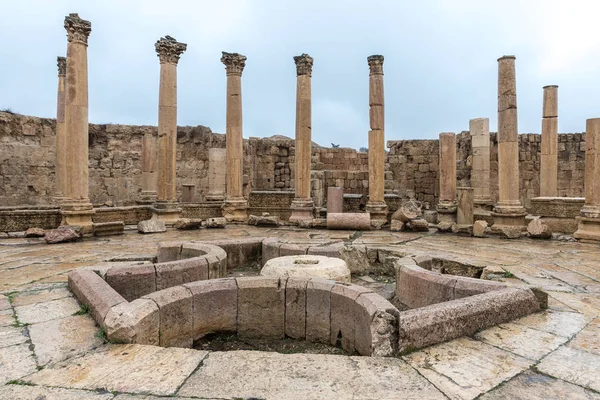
[0,226,600,400]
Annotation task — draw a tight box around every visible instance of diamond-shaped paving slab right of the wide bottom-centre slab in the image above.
[403,338,533,399]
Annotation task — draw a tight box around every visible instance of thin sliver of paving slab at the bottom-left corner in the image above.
[0,385,113,400]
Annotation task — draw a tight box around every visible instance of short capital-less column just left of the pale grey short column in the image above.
[436,132,456,222]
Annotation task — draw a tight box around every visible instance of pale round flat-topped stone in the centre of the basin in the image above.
[260,255,350,282]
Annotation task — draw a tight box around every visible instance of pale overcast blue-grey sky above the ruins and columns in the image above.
[0,0,600,148]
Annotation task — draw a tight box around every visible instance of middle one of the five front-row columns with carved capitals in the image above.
[221,52,248,222]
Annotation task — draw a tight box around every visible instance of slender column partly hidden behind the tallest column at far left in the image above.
[54,57,67,203]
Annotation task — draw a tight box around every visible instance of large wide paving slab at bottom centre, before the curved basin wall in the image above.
[178,350,445,400]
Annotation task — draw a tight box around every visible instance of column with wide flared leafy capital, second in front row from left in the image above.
[153,36,187,224]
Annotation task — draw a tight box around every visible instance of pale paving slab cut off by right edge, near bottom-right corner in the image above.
[537,346,600,391]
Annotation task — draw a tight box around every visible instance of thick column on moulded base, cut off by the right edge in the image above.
[573,118,600,240]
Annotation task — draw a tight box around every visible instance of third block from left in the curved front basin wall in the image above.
[183,278,238,340]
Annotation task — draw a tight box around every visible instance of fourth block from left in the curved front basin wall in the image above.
[236,277,286,338]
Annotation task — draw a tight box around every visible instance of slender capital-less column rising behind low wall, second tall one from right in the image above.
[540,85,558,197]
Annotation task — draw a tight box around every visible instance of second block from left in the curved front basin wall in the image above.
[142,286,194,347]
